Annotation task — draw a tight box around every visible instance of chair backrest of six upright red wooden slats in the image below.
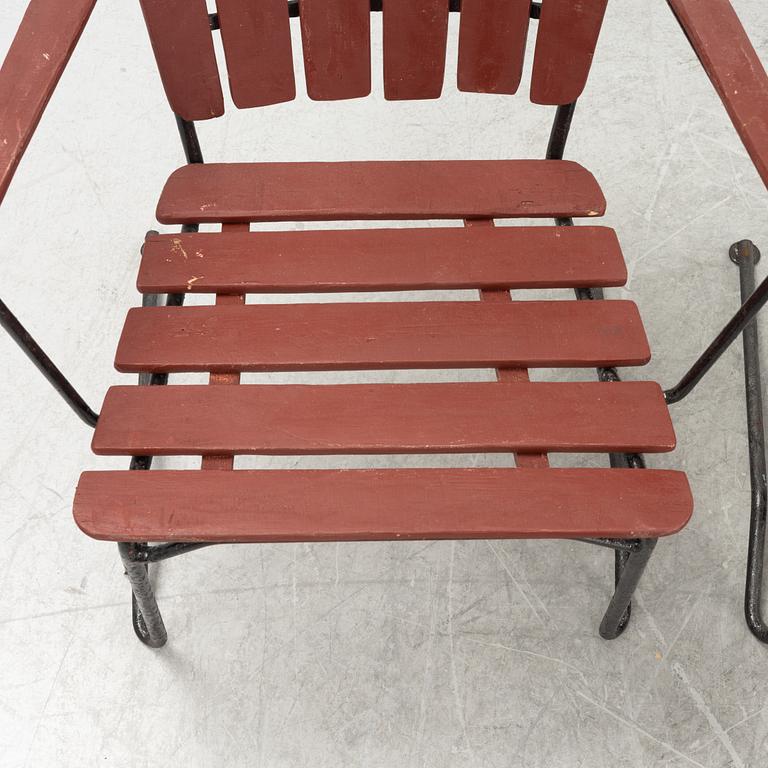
[140,0,608,120]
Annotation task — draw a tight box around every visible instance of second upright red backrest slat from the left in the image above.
[216,0,296,109]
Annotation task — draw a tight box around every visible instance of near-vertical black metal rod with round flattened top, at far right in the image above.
[729,240,768,643]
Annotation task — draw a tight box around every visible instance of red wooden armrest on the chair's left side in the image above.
[0,0,96,202]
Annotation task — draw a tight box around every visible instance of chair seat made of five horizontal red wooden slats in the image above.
[74,161,692,542]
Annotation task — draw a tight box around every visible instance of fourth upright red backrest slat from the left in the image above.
[383,0,448,100]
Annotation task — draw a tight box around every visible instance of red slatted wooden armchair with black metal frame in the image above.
[0,0,768,647]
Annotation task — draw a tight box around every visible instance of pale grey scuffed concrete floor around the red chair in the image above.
[0,0,768,768]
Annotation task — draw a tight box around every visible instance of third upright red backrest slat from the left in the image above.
[301,0,371,101]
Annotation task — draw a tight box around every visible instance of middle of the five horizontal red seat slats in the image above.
[115,301,650,373]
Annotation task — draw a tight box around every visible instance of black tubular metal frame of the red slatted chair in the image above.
[0,0,768,648]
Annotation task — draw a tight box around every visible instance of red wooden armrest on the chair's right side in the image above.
[667,0,768,186]
